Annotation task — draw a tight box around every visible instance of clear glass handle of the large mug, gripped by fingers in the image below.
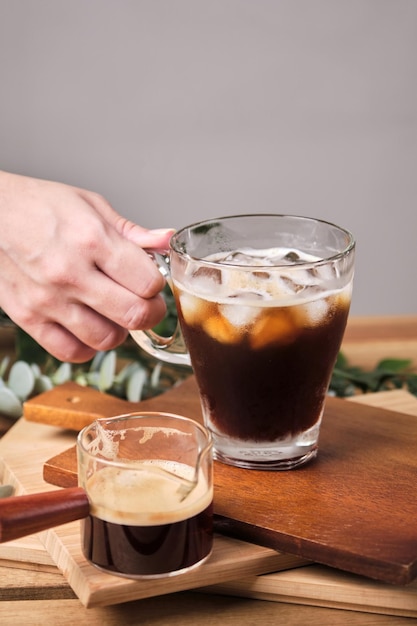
[129,250,191,366]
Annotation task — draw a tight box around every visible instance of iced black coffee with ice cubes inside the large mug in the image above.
[174,248,351,469]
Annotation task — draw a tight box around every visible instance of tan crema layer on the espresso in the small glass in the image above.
[85,461,213,526]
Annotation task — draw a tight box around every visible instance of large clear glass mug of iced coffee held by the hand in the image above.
[131,214,355,470]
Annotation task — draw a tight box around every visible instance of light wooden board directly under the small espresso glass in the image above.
[0,418,306,607]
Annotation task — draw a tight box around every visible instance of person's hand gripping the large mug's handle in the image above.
[0,172,173,362]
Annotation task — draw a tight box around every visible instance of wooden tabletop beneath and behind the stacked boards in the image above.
[0,315,417,626]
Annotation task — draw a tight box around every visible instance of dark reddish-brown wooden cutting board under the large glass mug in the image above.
[25,377,417,584]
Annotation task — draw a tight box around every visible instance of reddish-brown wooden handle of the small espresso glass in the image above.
[0,487,90,543]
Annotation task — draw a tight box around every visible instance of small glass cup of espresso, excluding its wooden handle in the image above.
[77,412,213,579]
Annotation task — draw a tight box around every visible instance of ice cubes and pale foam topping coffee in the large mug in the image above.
[175,248,352,346]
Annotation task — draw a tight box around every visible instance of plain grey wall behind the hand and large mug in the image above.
[0,0,417,314]
